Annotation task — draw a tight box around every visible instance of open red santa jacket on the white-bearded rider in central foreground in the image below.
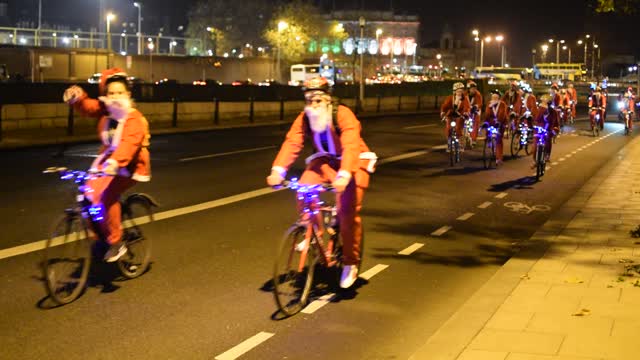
[272,105,377,187]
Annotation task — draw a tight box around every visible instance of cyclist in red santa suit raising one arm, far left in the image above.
[63,68,151,262]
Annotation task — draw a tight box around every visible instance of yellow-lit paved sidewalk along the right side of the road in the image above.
[410,137,640,360]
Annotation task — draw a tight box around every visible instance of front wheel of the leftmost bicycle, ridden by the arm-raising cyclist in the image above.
[42,213,91,305]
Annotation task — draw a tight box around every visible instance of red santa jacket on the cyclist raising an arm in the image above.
[73,93,151,182]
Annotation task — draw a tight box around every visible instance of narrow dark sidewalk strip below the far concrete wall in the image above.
[0,110,438,150]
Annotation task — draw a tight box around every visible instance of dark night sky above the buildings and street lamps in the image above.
[6,0,640,66]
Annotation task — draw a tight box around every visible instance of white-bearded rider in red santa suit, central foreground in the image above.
[267,77,377,288]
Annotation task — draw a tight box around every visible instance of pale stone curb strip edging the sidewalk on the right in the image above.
[409,133,640,360]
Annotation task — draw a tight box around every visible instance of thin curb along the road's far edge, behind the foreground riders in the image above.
[0,110,438,151]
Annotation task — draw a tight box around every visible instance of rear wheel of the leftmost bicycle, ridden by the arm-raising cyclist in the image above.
[118,194,153,279]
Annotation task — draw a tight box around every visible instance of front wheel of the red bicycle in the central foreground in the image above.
[273,225,316,316]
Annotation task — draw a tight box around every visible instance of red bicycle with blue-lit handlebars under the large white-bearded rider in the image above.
[273,178,364,316]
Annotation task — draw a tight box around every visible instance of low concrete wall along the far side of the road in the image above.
[1,96,444,131]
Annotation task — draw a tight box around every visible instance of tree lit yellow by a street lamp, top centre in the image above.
[263,0,328,62]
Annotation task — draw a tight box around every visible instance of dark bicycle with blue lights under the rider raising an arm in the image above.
[42,167,158,305]
